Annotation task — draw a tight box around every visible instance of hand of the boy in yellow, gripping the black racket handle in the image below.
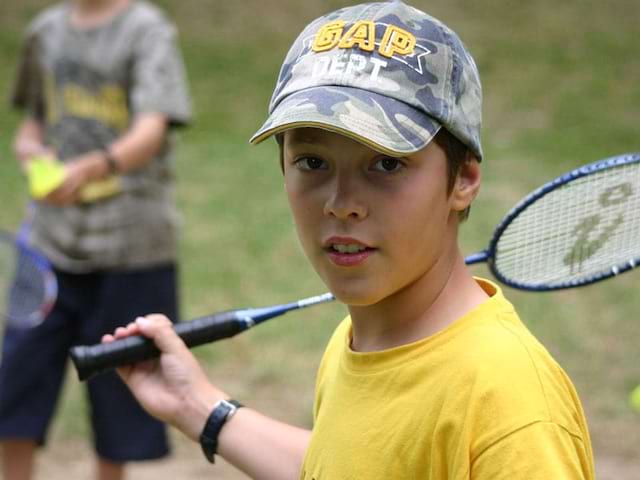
[102,314,226,441]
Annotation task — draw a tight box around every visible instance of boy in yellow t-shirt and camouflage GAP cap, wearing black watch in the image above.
[104,2,593,480]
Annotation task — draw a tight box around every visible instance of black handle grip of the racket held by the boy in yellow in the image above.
[69,310,248,381]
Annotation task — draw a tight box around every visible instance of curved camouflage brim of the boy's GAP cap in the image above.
[250,86,441,156]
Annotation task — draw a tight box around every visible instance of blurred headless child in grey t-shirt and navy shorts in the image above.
[0,0,191,480]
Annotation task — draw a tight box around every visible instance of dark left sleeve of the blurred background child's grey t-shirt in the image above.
[11,33,44,120]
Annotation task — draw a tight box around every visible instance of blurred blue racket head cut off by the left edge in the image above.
[0,231,58,328]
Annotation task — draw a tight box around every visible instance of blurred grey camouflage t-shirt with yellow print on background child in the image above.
[13,1,191,272]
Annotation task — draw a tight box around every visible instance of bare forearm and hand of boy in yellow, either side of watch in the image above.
[103,315,311,480]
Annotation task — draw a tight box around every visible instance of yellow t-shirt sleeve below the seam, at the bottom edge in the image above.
[470,422,594,480]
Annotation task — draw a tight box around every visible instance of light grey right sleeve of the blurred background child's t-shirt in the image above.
[131,22,191,126]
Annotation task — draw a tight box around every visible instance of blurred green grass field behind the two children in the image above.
[0,0,640,478]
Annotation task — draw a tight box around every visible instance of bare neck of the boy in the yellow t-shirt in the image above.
[349,248,488,352]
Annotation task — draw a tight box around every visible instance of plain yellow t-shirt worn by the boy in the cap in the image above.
[301,279,594,480]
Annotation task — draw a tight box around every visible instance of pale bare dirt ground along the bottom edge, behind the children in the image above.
[15,434,640,480]
